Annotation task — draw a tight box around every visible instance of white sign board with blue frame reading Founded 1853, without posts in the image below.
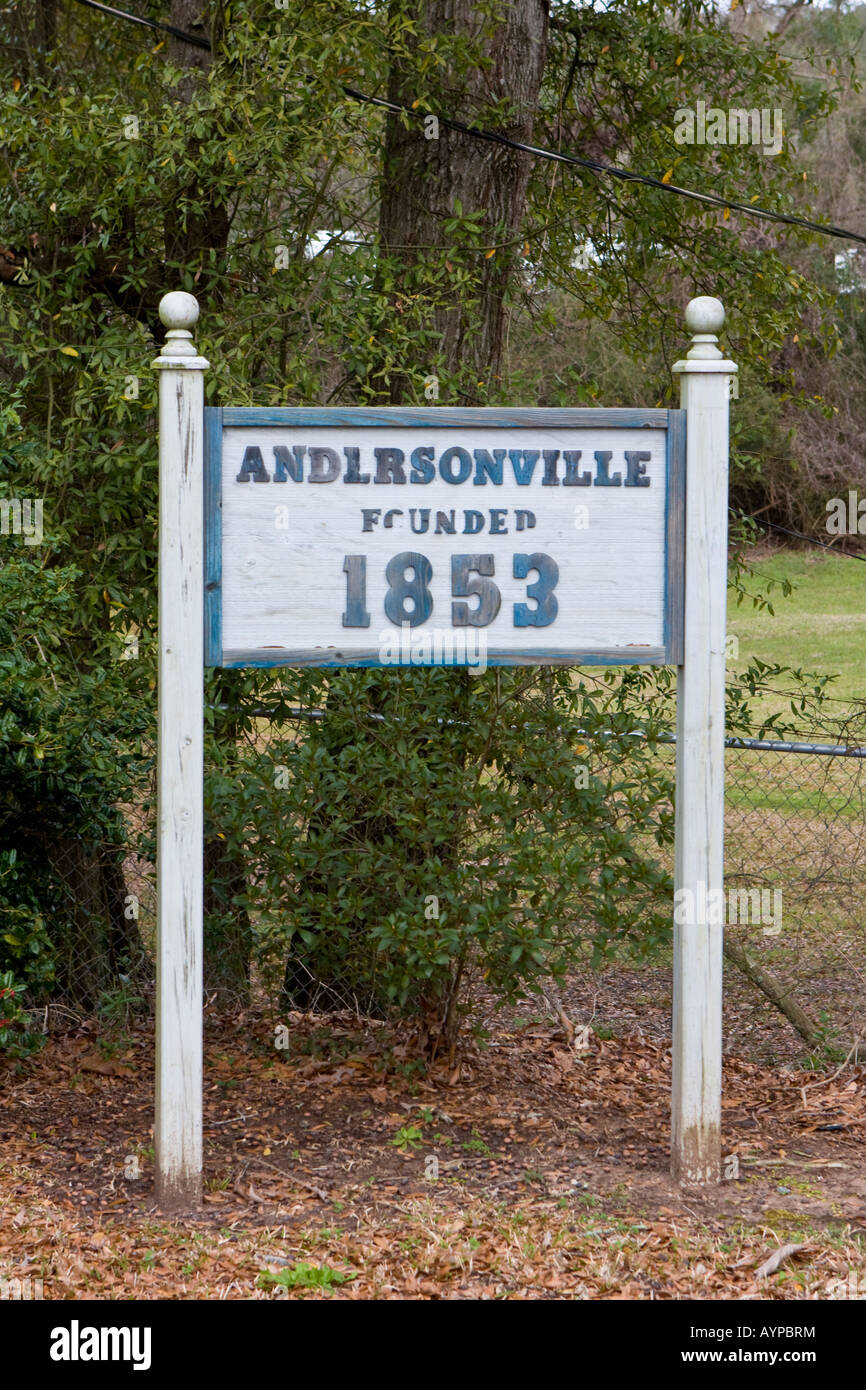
[207,409,683,669]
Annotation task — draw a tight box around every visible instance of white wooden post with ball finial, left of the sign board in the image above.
[153,292,209,1211]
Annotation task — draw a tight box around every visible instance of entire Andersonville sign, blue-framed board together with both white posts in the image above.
[154,291,737,1211]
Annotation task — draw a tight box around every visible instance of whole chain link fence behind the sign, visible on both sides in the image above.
[18,706,866,1055]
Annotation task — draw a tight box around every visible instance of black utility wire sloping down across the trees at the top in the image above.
[69,0,866,246]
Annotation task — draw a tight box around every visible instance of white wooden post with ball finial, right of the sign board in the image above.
[671,296,737,1183]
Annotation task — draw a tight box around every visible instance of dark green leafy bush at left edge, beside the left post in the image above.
[0,555,150,1045]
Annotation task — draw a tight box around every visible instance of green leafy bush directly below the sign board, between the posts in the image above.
[244,669,673,1052]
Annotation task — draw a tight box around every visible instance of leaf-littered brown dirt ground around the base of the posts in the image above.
[0,969,866,1300]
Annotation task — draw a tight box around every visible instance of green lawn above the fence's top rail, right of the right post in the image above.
[728,550,866,708]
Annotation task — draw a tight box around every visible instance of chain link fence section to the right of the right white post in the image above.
[726,728,866,1058]
